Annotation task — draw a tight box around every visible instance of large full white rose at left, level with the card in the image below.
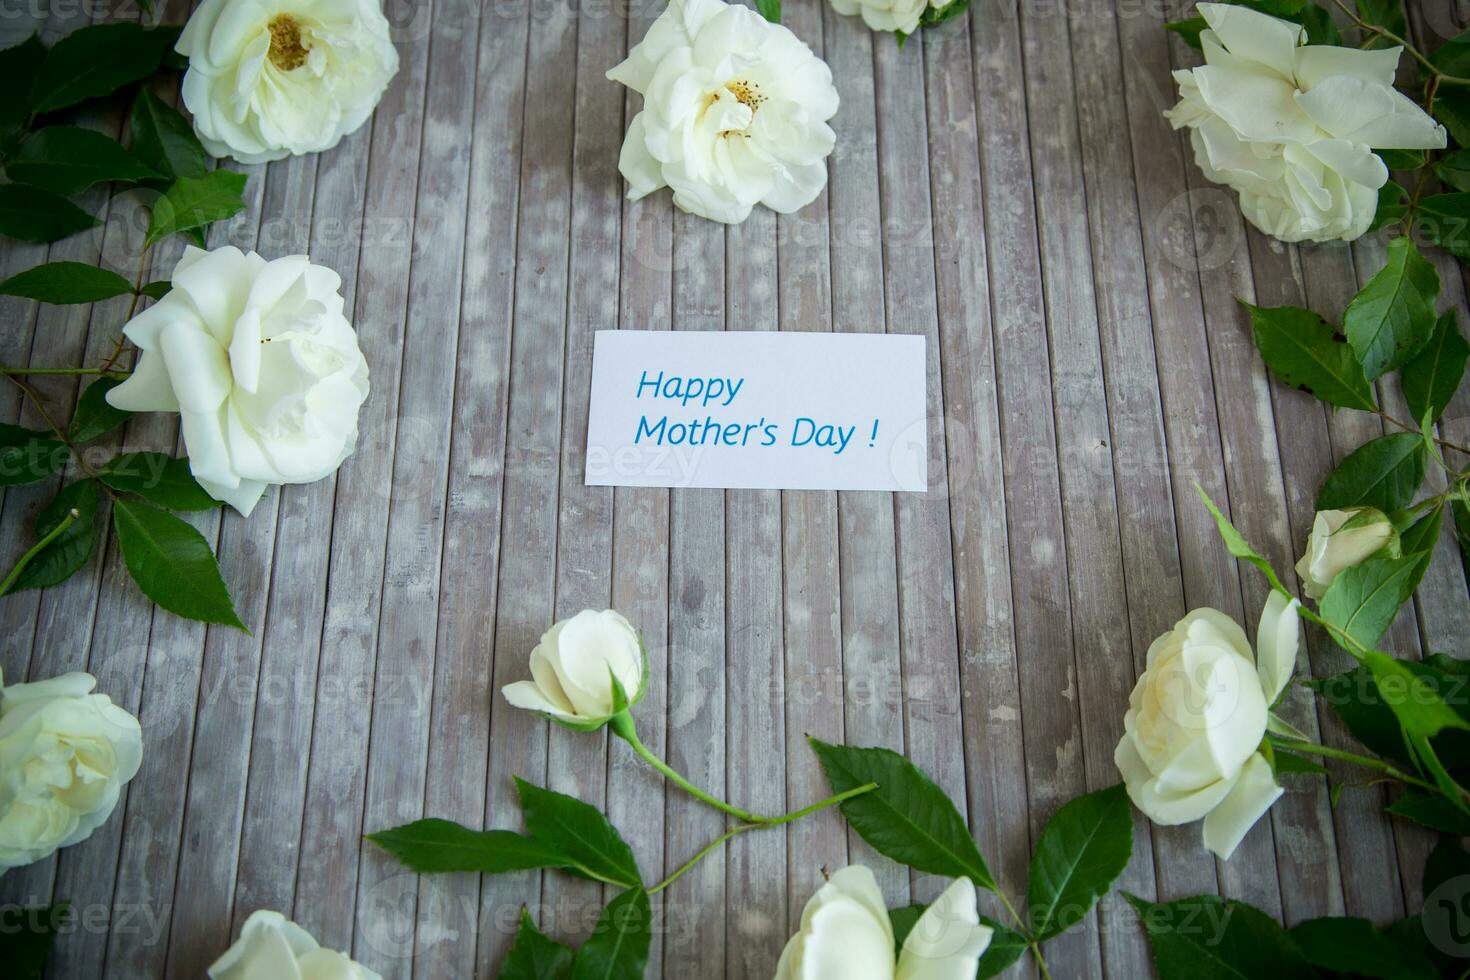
[107,245,368,514]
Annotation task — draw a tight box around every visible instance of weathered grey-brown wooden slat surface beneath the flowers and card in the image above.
[0,0,1470,980]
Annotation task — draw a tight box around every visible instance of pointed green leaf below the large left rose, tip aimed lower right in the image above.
[112,498,248,632]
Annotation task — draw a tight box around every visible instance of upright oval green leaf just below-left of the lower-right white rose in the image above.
[1026,785,1133,939]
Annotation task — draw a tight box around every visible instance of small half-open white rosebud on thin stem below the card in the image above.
[501,610,645,729]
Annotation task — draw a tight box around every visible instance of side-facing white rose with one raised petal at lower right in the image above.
[1113,592,1301,858]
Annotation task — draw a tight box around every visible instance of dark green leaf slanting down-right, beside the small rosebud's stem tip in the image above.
[807,738,995,892]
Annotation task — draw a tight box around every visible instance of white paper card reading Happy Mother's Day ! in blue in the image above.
[587,331,928,491]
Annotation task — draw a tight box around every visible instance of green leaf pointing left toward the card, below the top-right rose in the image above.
[1241,303,1377,411]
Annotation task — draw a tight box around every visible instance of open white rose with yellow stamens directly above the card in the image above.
[607,0,838,222]
